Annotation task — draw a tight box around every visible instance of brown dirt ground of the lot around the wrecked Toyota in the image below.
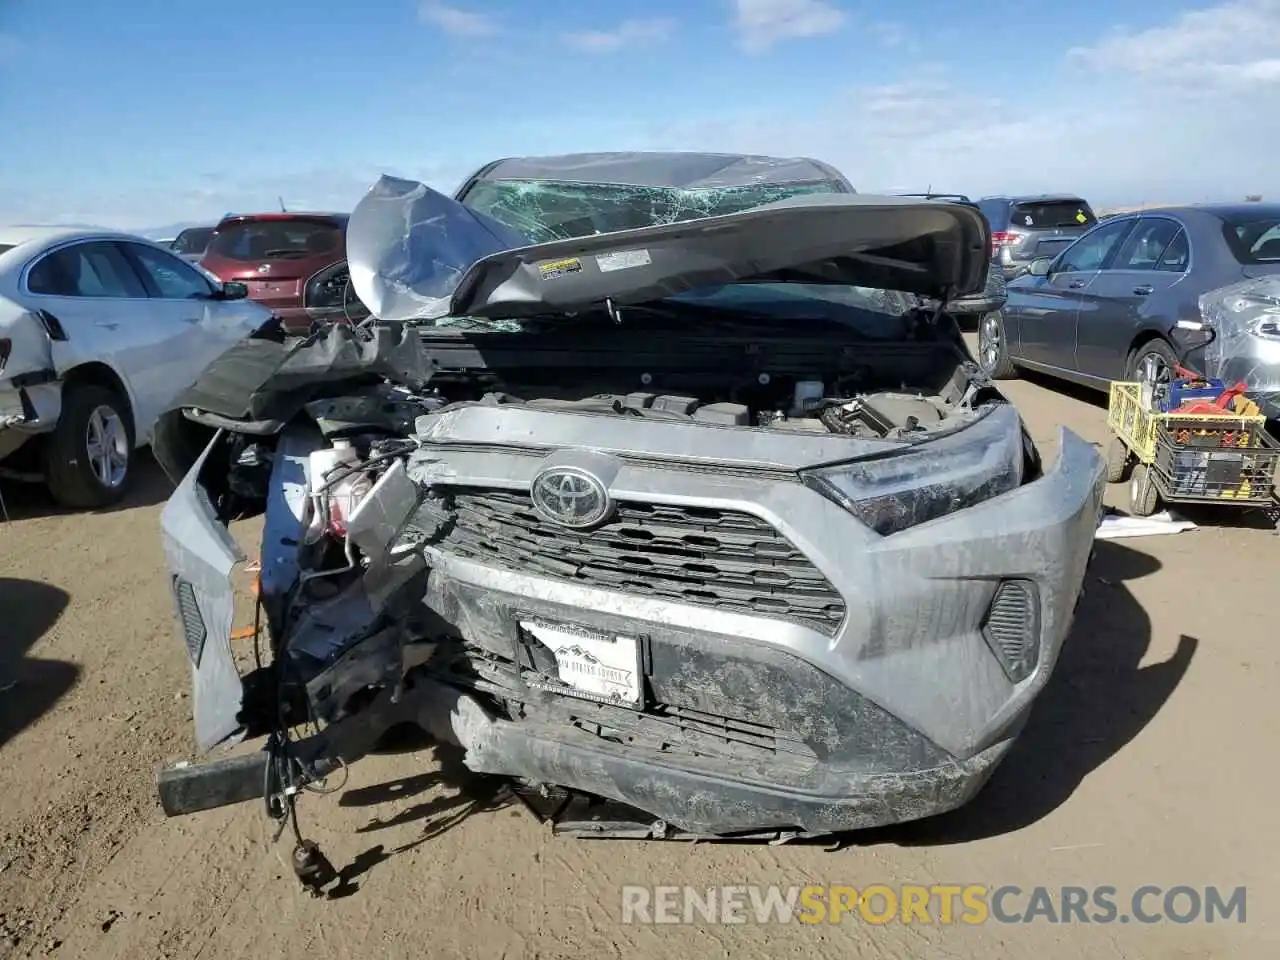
[0,358,1280,960]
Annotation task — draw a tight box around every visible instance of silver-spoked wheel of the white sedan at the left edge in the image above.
[45,384,133,509]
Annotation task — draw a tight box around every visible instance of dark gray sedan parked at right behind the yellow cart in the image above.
[978,204,1280,417]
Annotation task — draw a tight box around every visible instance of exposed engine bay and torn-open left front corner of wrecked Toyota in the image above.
[160,316,1032,757]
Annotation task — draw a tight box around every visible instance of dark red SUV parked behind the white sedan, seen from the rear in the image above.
[200,212,369,334]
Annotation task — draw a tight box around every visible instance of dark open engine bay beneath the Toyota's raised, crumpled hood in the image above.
[386,317,992,439]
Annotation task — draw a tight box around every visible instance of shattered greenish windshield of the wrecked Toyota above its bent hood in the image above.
[463,180,845,243]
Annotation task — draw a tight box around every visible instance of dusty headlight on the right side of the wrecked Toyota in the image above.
[803,403,1027,536]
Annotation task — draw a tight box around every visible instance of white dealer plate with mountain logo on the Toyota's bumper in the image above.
[520,620,643,707]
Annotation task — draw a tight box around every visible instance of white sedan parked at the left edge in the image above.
[0,228,271,508]
